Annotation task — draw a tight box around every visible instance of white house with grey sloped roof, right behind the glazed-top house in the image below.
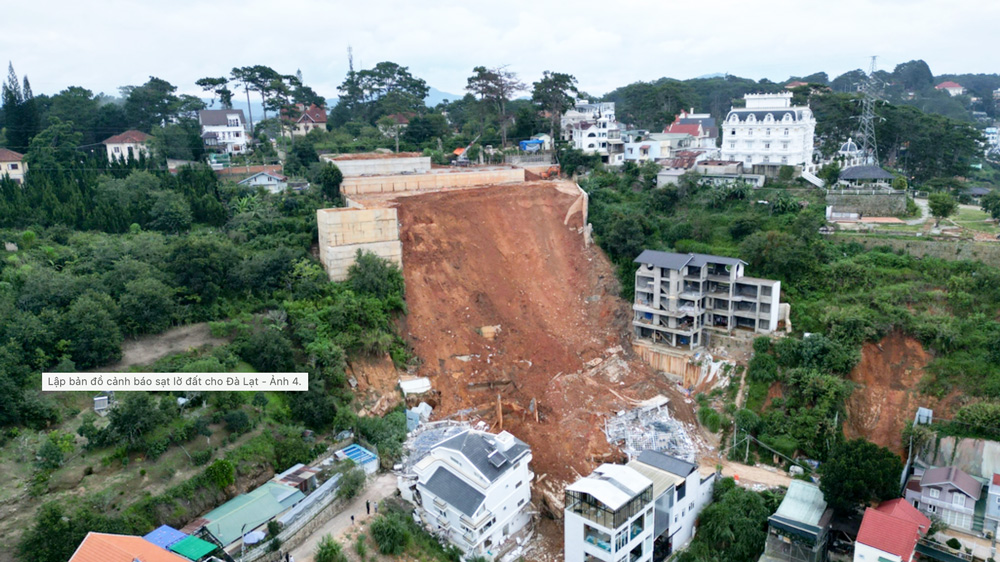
[628,451,716,559]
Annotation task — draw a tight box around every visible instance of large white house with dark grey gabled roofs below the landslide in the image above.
[401,429,535,558]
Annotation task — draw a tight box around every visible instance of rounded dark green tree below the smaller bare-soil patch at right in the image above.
[819,439,903,514]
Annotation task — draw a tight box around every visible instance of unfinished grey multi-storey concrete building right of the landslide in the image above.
[632,250,781,349]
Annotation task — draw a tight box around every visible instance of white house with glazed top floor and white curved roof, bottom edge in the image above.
[563,464,654,562]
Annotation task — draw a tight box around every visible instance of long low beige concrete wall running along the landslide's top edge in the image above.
[337,163,524,195]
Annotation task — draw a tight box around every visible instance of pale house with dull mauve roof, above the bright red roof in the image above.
[905,466,983,532]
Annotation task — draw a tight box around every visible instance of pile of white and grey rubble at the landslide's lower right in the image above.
[604,400,697,462]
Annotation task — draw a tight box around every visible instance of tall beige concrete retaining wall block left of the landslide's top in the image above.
[316,208,403,281]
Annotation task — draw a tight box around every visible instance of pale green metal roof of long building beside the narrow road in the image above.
[198,482,306,546]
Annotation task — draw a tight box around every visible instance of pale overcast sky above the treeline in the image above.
[0,0,1000,97]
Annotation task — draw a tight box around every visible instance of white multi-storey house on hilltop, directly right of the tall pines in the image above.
[562,102,624,165]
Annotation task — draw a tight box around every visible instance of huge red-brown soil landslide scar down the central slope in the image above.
[397,182,693,481]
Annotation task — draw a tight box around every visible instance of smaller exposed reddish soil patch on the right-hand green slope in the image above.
[844,332,959,457]
